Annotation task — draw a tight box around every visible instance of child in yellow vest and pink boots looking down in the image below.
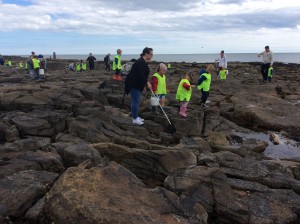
[176,72,195,117]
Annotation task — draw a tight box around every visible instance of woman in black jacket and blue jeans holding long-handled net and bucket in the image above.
[125,47,153,125]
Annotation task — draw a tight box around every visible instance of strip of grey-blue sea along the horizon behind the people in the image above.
[49,53,300,64]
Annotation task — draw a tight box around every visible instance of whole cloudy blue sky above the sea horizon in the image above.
[0,0,300,55]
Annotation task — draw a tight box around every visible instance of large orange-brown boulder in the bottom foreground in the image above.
[43,163,207,224]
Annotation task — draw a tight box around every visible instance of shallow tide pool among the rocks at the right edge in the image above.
[234,132,300,161]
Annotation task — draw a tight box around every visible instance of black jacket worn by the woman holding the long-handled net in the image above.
[125,57,150,94]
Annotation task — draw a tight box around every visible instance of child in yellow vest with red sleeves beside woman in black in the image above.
[151,63,168,114]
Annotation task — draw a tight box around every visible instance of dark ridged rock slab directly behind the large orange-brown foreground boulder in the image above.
[92,143,197,186]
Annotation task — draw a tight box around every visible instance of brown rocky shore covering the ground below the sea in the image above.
[0,57,300,224]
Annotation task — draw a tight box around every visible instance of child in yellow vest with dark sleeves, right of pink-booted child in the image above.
[197,64,215,107]
